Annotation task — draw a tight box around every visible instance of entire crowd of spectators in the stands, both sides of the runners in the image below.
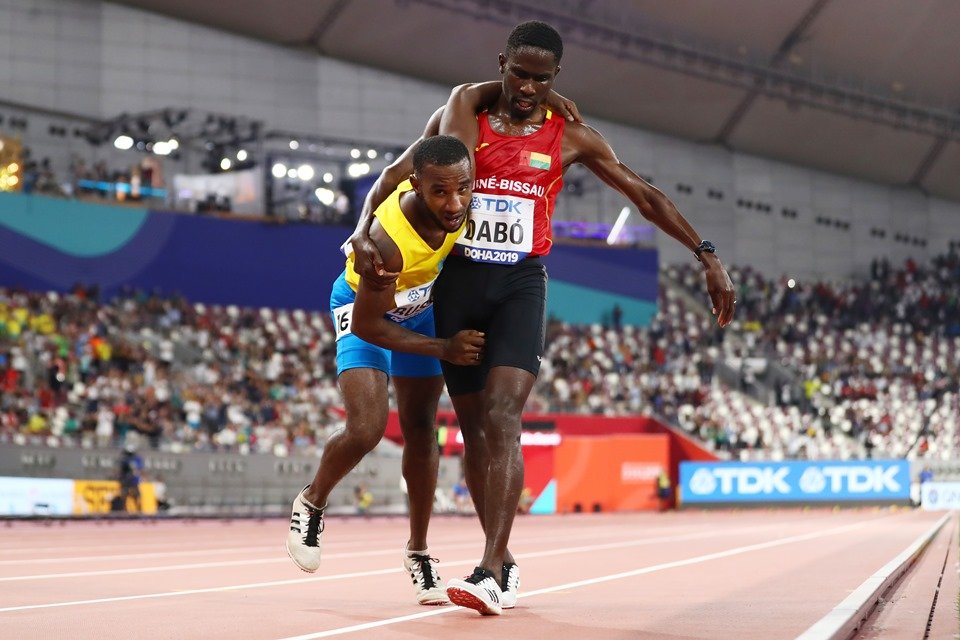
[0,248,960,459]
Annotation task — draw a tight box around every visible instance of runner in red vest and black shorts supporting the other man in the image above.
[351,21,736,614]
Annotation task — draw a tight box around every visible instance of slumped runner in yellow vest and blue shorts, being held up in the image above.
[287,136,484,604]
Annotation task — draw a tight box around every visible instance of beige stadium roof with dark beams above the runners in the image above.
[118,0,960,201]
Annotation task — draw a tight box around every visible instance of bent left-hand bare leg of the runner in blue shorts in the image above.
[304,368,387,507]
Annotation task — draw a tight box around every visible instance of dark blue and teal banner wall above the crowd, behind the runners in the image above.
[0,193,660,326]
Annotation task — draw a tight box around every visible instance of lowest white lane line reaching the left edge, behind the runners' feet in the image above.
[0,525,778,582]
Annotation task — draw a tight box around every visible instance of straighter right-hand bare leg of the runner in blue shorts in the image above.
[393,376,443,551]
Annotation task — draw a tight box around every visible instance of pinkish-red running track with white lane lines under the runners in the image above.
[0,509,942,640]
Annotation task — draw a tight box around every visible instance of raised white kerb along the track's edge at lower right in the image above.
[797,513,953,640]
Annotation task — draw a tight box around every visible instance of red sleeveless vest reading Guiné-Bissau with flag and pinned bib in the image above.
[454,111,566,264]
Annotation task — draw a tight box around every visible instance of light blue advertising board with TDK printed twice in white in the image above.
[680,460,910,504]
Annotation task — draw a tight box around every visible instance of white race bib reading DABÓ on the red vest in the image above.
[457,192,534,264]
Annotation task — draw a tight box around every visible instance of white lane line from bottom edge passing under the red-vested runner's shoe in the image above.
[281,522,869,640]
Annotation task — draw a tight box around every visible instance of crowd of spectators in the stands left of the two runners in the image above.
[0,287,343,455]
